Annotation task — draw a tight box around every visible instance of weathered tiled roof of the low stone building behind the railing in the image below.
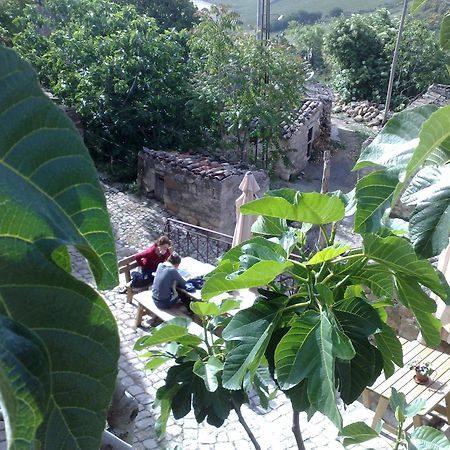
[143,147,258,180]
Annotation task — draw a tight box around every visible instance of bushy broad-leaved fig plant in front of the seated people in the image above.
[139,189,448,446]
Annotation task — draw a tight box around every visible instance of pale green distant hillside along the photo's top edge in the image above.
[209,0,403,26]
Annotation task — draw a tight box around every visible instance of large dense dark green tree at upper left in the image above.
[14,0,197,176]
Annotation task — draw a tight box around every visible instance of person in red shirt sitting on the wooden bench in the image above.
[131,236,172,287]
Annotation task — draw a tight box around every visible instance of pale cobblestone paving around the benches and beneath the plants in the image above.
[0,186,389,450]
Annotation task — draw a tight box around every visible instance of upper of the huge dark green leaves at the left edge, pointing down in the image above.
[0,48,117,289]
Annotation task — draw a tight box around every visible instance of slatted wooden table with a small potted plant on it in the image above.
[363,338,450,429]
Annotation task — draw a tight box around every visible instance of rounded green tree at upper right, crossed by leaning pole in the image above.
[324,10,449,106]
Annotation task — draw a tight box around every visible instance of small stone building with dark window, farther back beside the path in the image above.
[275,84,332,181]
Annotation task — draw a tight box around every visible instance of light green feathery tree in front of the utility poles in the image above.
[189,6,303,166]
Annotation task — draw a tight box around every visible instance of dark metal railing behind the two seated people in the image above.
[164,219,233,264]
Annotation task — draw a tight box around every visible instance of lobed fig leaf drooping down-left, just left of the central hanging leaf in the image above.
[222,298,287,390]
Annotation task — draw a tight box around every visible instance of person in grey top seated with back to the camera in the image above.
[152,253,189,309]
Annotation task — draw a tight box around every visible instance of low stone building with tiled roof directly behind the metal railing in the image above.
[138,147,269,234]
